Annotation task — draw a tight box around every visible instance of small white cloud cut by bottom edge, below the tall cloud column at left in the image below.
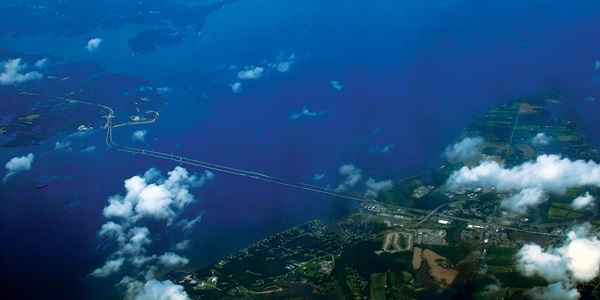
[129,279,190,300]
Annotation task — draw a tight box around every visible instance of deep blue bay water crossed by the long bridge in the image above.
[0,0,600,298]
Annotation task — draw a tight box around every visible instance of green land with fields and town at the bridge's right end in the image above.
[177,92,600,299]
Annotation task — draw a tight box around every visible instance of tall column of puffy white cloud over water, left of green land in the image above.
[90,166,214,299]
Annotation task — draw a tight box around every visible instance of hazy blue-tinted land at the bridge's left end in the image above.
[0,50,168,147]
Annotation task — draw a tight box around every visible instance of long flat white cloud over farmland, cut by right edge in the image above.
[447,155,600,212]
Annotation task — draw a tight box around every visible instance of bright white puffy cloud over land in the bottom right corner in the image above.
[516,223,600,299]
